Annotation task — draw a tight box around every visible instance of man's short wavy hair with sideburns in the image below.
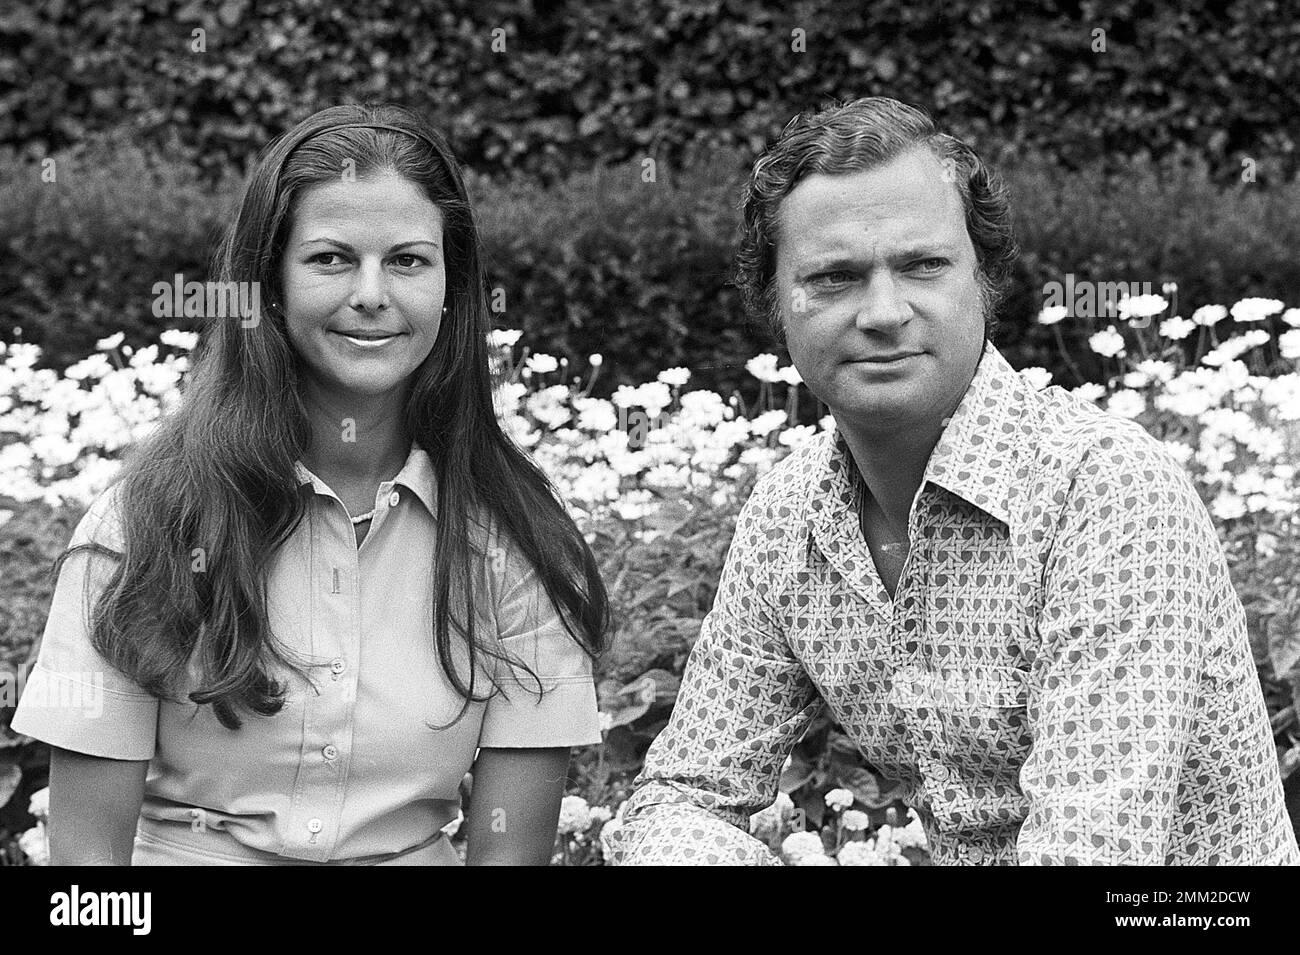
[733,96,1019,343]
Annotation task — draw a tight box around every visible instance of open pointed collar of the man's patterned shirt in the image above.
[810,342,1034,535]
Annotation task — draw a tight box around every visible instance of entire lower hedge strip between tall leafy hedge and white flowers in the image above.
[0,139,1300,400]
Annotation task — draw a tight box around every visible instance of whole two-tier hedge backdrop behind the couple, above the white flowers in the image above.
[0,0,1300,394]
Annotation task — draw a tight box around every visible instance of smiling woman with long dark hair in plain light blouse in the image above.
[13,107,608,864]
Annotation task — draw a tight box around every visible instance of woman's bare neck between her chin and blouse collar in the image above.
[303,392,411,494]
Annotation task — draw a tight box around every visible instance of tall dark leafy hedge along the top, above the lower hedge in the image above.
[0,0,1300,179]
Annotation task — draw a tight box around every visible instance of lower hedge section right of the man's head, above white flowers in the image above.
[997,157,1300,386]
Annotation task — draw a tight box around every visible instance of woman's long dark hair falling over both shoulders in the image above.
[68,105,610,729]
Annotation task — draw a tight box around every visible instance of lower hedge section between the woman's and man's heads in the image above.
[476,164,763,394]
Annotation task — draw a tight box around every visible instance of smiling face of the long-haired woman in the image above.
[280,172,447,403]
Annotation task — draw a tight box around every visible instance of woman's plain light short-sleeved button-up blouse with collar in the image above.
[13,447,601,864]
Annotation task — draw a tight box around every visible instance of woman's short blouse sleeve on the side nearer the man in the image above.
[478,527,601,748]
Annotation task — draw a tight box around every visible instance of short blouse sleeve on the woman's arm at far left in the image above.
[12,486,159,760]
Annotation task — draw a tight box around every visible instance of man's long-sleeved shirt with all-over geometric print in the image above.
[611,344,1300,865]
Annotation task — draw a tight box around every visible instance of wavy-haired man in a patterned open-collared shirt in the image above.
[611,97,1300,864]
